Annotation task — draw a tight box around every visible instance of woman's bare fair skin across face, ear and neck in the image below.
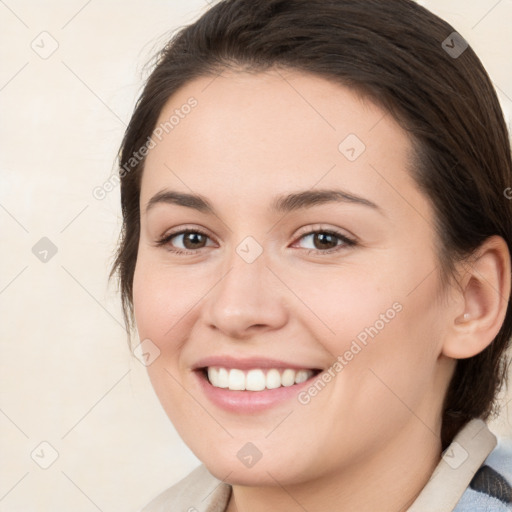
[133,70,510,512]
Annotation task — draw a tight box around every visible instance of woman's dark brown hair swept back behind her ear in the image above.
[111,0,512,447]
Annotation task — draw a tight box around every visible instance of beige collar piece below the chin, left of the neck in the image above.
[141,464,231,512]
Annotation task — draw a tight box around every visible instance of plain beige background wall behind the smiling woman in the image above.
[0,0,512,512]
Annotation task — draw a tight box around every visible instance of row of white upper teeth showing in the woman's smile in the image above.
[208,366,314,391]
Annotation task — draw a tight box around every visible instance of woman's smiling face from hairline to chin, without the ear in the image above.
[133,71,453,485]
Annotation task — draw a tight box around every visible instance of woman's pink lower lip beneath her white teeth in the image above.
[194,371,318,413]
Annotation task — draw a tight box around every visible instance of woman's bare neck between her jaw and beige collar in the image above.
[226,418,441,512]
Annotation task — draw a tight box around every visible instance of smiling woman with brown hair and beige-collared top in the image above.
[113,0,512,512]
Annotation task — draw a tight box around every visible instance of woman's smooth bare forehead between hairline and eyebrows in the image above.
[141,70,422,218]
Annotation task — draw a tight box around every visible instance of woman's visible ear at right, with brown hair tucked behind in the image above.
[442,236,511,359]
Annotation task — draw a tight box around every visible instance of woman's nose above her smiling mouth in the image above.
[203,249,288,339]
